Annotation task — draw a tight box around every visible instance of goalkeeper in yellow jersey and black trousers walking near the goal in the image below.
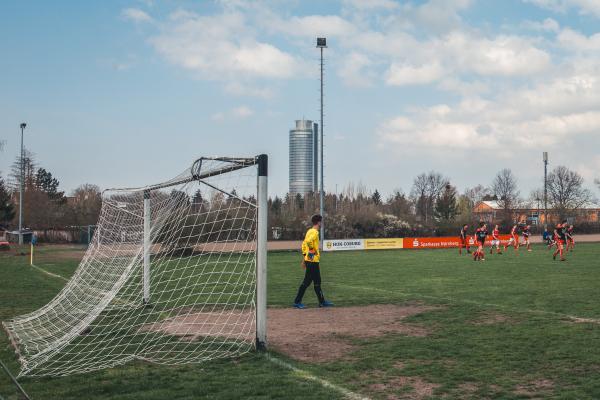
[294,214,333,309]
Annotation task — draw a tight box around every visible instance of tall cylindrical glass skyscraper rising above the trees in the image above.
[289,119,319,194]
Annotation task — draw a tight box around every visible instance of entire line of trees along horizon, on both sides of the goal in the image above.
[0,151,600,239]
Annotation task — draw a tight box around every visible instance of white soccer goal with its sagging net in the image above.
[4,155,268,376]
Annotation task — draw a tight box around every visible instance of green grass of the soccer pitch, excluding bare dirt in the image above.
[0,244,600,399]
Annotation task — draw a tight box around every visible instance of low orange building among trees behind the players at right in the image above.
[473,200,600,225]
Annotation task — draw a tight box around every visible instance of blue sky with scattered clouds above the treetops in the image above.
[0,0,600,202]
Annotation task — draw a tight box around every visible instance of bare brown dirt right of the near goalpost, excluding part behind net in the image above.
[268,305,433,362]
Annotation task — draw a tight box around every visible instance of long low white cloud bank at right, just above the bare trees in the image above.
[378,65,600,151]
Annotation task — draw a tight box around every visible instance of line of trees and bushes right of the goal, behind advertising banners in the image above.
[269,166,600,239]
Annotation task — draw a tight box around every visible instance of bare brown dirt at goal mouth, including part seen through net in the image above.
[142,305,435,362]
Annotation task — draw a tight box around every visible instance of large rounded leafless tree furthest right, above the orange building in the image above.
[548,165,593,218]
